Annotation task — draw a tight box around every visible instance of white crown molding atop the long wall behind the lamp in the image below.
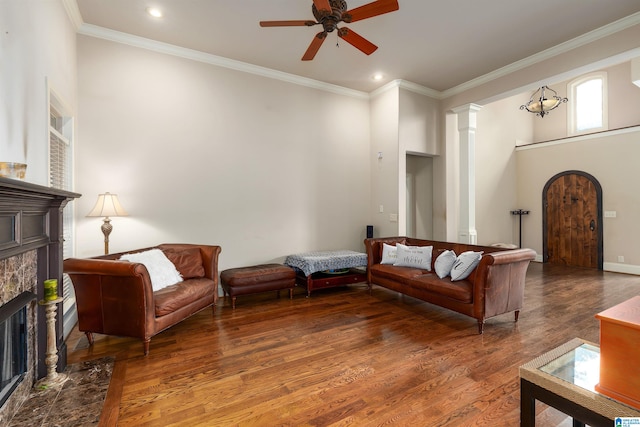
[78,23,369,100]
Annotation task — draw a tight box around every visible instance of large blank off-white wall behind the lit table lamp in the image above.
[76,36,371,269]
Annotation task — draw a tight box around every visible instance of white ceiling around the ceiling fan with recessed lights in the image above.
[76,0,640,92]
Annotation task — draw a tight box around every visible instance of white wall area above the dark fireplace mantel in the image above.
[0,0,76,185]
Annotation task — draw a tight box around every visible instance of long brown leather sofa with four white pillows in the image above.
[364,237,536,334]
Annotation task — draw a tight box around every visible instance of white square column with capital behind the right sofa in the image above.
[453,104,482,245]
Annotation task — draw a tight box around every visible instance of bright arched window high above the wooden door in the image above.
[567,72,609,135]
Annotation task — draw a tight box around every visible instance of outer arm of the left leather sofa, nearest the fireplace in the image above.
[63,258,155,338]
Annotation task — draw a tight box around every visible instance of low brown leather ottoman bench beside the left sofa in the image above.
[220,264,296,309]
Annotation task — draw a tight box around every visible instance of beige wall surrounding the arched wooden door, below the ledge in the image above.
[516,128,640,274]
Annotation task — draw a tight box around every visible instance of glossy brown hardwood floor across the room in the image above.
[68,263,640,426]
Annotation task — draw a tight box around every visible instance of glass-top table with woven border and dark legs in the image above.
[520,338,640,427]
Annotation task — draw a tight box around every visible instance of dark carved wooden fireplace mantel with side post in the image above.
[0,178,80,378]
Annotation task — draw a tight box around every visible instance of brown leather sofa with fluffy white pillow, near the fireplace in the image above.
[64,244,221,355]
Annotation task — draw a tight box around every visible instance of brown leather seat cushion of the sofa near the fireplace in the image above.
[153,277,215,317]
